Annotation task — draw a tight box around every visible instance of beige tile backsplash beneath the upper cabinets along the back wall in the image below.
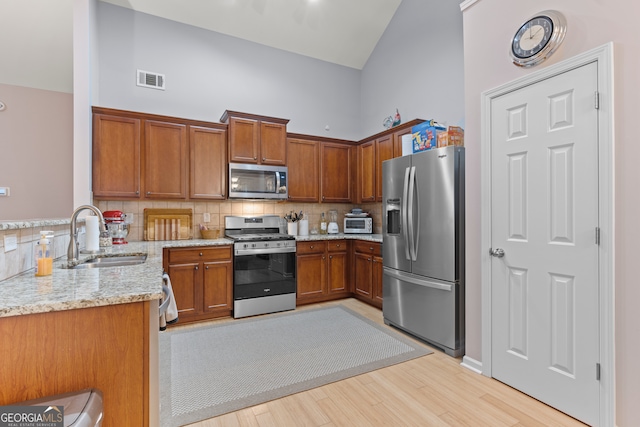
[95,200,382,241]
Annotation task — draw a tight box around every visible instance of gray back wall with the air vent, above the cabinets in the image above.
[94,2,360,139]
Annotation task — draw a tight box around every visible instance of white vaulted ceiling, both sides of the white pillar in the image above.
[0,0,402,92]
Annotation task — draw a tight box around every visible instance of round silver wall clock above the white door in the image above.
[511,10,567,67]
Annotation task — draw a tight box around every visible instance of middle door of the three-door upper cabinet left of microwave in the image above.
[144,120,188,199]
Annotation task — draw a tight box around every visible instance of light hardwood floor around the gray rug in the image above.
[175,299,584,427]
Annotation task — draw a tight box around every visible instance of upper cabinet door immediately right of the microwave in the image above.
[287,138,320,203]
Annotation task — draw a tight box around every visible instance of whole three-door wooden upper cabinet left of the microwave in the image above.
[92,107,227,200]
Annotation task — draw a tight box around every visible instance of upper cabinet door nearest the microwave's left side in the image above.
[189,126,227,200]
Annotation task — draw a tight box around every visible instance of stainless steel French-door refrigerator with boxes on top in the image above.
[382,146,464,357]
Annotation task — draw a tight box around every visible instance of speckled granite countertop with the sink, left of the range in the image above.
[0,238,232,317]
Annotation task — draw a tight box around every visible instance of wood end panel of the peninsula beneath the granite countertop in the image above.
[0,301,149,427]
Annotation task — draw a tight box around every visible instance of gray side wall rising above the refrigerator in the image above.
[361,0,464,135]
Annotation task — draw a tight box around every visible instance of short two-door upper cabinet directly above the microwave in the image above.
[220,110,289,166]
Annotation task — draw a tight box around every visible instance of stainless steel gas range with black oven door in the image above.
[224,215,296,318]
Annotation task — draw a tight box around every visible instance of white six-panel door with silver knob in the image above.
[491,62,599,425]
